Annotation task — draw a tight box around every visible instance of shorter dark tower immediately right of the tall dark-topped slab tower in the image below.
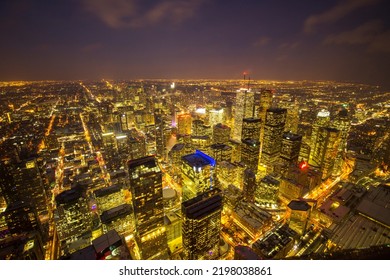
[280,132,302,172]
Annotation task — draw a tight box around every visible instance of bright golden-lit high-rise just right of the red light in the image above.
[309,127,340,179]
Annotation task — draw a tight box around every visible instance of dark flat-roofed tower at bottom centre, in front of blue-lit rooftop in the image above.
[182,189,223,260]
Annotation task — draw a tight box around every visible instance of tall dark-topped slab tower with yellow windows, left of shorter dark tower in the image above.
[260,108,287,174]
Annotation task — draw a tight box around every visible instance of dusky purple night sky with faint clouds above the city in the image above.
[0,0,390,88]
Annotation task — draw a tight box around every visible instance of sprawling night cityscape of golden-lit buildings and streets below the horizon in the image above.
[0,79,390,260]
